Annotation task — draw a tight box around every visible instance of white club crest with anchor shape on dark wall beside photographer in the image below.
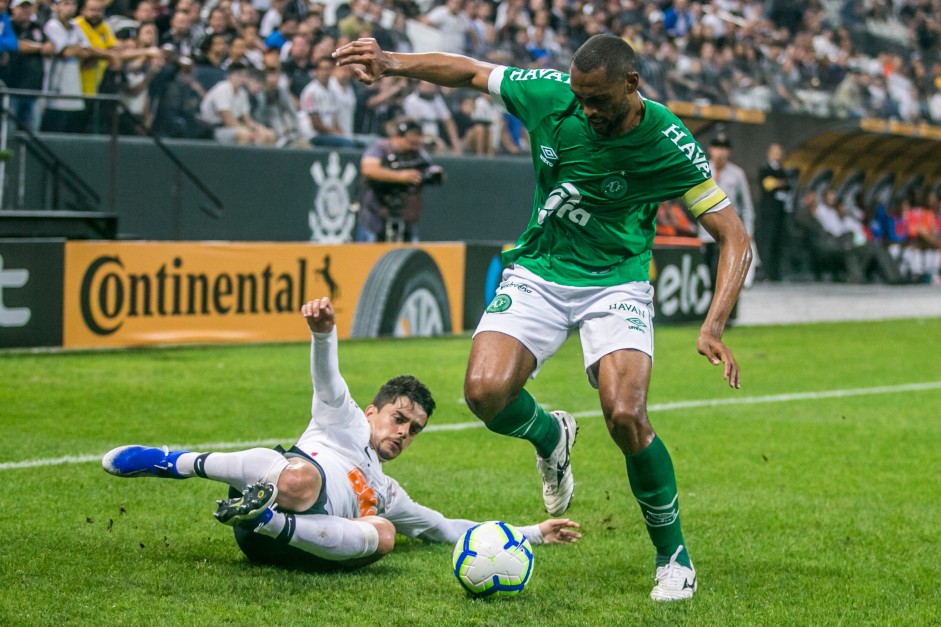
[307,152,356,244]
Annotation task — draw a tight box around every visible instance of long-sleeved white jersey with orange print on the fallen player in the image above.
[296,329,504,543]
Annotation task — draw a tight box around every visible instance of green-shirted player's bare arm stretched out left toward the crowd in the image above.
[333,39,496,93]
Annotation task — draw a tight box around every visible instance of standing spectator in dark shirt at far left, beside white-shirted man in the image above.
[0,0,55,131]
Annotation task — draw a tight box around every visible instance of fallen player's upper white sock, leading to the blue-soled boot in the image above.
[176,448,288,491]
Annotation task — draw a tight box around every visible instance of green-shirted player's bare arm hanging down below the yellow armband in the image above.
[696,206,752,389]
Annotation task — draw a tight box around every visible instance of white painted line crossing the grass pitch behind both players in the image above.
[0,381,941,471]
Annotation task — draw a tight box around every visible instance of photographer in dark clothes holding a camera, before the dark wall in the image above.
[356,117,444,242]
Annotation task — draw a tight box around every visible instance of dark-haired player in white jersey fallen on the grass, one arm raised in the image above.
[102,298,581,570]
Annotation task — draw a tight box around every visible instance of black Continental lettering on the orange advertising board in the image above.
[79,255,308,336]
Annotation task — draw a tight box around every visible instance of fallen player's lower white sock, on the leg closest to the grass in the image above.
[255,511,379,562]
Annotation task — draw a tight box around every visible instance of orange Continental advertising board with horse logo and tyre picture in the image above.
[63,242,464,348]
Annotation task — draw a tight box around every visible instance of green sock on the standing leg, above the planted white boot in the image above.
[625,436,690,567]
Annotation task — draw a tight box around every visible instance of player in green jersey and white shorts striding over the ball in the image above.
[334,35,751,601]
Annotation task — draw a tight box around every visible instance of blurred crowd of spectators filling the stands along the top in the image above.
[0,0,941,149]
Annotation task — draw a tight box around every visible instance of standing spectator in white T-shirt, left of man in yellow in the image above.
[40,0,89,133]
